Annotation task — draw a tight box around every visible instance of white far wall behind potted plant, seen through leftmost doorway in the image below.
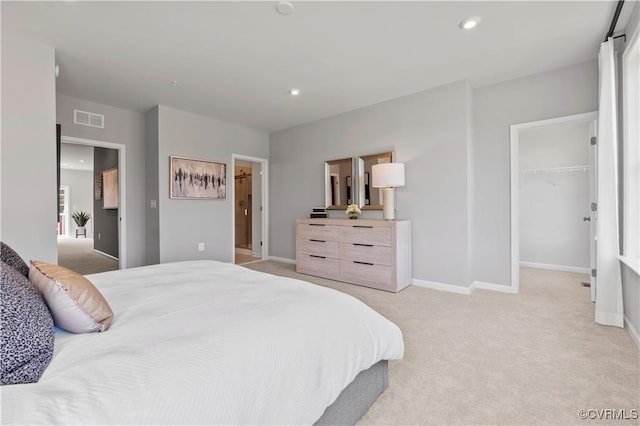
[60,169,93,237]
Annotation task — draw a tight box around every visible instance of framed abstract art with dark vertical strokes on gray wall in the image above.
[169,156,227,200]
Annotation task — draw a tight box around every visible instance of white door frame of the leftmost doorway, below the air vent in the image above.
[60,135,127,269]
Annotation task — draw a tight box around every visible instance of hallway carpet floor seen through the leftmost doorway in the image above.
[58,237,118,275]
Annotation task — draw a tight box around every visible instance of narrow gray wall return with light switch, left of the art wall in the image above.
[145,107,160,265]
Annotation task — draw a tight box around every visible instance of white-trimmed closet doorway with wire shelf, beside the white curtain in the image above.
[511,112,597,299]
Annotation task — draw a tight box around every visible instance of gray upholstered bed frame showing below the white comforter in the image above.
[315,360,389,425]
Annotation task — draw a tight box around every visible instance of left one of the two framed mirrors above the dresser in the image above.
[324,158,355,210]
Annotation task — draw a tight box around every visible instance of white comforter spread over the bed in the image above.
[1,261,404,424]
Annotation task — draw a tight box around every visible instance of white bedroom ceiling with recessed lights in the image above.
[2,1,632,131]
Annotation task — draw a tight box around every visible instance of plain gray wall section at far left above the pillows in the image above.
[0,34,58,263]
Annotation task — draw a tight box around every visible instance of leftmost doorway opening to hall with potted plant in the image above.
[58,136,126,275]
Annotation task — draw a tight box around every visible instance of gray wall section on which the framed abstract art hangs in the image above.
[156,105,269,263]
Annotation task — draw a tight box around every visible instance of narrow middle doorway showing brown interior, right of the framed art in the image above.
[231,154,268,264]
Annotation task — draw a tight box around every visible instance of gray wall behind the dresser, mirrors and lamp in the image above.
[270,82,471,286]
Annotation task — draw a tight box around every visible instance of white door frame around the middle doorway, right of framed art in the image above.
[231,154,269,263]
